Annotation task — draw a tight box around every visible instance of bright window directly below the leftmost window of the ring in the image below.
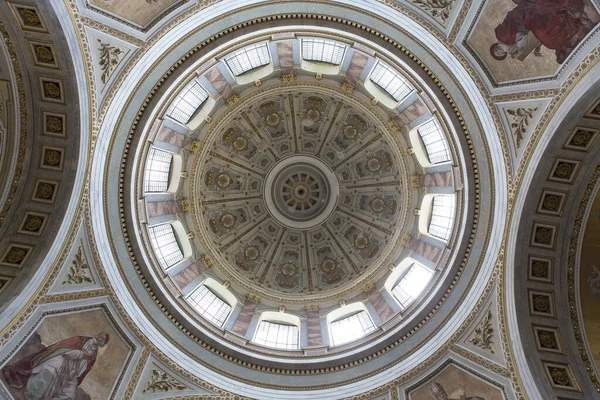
[148,221,192,270]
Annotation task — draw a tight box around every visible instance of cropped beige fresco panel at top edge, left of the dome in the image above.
[90,0,181,27]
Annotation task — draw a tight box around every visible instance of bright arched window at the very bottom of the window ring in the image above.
[252,311,300,350]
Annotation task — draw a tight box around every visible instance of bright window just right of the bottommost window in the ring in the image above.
[327,303,376,346]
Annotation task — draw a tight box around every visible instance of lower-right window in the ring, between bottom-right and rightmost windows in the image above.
[384,257,434,310]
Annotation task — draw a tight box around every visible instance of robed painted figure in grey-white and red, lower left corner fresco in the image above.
[2,332,109,400]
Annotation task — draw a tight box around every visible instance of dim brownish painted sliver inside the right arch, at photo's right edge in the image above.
[579,192,600,374]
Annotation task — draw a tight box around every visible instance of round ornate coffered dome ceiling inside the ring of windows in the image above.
[190,83,414,302]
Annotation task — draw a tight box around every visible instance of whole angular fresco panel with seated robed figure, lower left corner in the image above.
[1,309,131,400]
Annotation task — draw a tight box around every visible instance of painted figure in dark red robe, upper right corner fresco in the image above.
[490,0,597,64]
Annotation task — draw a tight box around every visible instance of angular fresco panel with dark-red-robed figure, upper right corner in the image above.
[468,0,600,83]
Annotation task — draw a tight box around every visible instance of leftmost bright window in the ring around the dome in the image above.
[143,146,183,193]
